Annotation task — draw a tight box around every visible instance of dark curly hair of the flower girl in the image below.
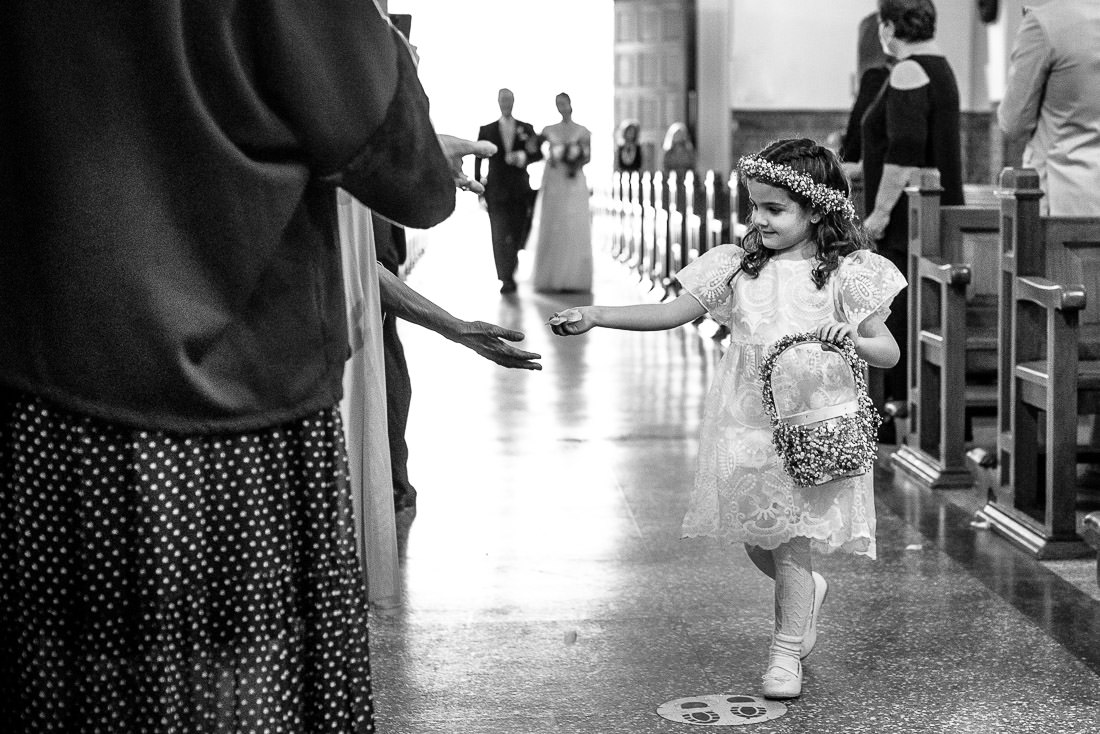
[741,138,872,289]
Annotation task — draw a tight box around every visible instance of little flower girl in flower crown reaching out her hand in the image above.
[549,139,905,699]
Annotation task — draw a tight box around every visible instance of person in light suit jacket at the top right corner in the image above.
[997,0,1100,217]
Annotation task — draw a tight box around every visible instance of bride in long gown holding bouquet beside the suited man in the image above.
[528,92,592,293]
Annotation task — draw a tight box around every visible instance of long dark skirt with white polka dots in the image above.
[0,393,374,734]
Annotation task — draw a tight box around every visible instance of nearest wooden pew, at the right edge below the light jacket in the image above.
[982,168,1100,559]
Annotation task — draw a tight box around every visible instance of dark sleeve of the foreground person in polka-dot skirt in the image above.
[254,0,455,228]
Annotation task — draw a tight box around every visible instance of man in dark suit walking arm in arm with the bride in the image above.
[474,89,542,294]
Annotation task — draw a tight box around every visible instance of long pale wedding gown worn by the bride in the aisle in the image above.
[527,131,592,293]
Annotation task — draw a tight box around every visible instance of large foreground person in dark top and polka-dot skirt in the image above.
[0,5,475,734]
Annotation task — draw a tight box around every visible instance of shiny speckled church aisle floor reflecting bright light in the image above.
[372,202,1100,734]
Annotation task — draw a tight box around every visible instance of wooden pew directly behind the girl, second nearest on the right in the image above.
[890,168,1000,489]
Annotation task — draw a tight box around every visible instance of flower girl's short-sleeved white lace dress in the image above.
[677,244,905,558]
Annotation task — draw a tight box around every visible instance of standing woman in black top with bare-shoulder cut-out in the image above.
[861,0,963,435]
